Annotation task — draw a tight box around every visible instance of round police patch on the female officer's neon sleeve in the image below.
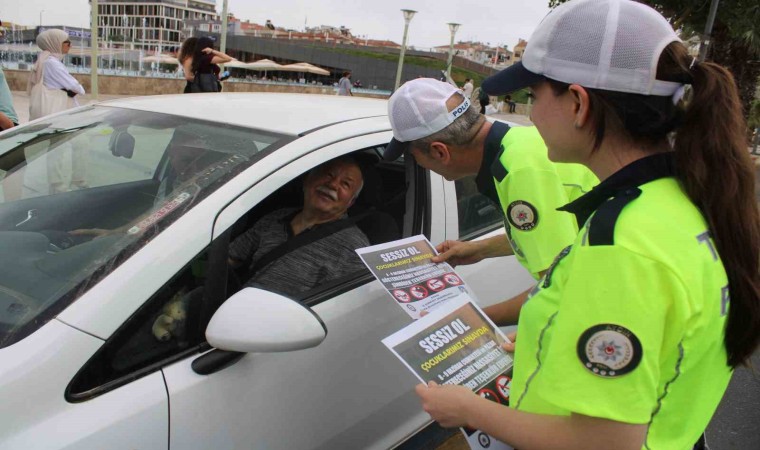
[577,323,643,378]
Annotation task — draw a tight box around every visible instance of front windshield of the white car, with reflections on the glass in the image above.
[0,106,292,348]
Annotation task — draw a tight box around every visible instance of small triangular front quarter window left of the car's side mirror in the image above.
[66,250,208,402]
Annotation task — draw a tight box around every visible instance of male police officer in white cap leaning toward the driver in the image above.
[384,78,598,325]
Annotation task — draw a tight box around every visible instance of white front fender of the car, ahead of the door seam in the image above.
[0,320,169,450]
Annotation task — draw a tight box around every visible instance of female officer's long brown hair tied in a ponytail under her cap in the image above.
[549,43,760,367]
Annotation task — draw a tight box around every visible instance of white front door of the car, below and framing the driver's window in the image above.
[164,132,445,449]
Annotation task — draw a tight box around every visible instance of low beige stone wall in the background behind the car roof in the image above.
[4,70,388,98]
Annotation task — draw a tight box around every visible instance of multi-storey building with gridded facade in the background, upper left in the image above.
[98,0,219,51]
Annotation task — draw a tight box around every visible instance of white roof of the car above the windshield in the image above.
[101,92,388,135]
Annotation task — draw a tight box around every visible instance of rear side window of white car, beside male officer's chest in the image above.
[455,175,504,239]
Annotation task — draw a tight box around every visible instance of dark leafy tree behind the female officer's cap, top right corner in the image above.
[549,0,760,113]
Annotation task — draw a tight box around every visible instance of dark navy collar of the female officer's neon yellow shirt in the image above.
[557,152,675,226]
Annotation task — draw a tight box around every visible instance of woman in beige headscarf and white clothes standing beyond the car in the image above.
[27,30,84,120]
